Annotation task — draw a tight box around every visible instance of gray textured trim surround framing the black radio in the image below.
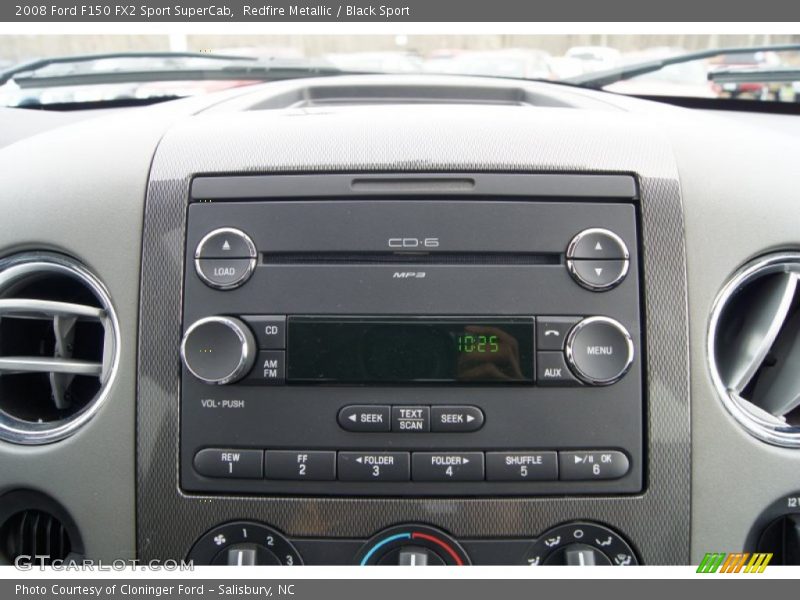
[137,94,691,564]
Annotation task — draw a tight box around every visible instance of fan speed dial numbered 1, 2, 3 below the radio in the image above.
[188,521,303,566]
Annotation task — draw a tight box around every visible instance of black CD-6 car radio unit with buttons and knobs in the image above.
[180,177,645,496]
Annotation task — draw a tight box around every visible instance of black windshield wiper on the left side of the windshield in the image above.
[0,52,342,88]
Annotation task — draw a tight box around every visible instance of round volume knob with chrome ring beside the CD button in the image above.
[181,317,256,385]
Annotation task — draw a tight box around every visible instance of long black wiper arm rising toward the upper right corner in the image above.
[562,44,800,90]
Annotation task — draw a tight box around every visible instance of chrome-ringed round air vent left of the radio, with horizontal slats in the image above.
[0,253,119,444]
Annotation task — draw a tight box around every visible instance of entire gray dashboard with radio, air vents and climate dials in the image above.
[0,75,800,565]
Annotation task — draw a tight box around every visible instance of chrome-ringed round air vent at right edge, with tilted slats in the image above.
[708,253,800,448]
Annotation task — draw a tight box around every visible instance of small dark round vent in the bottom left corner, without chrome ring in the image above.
[0,490,83,565]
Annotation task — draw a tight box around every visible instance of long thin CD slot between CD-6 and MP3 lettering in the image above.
[260,252,563,265]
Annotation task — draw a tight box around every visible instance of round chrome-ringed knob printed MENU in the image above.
[565,317,634,385]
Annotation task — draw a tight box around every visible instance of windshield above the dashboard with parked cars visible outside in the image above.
[0,35,800,107]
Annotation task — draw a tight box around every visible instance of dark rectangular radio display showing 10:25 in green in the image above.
[286,316,534,385]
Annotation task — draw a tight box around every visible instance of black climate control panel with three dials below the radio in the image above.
[187,521,639,567]
